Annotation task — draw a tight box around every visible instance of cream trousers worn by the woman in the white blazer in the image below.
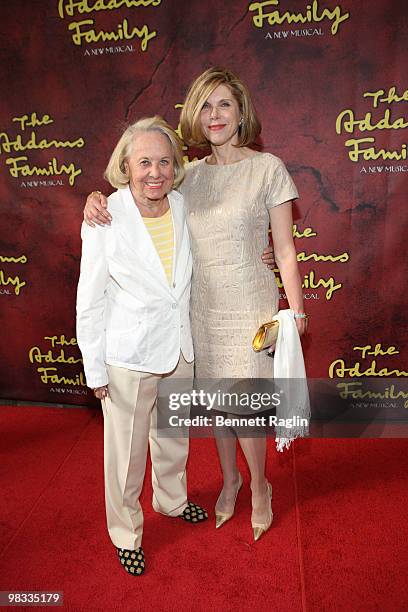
[102,353,193,550]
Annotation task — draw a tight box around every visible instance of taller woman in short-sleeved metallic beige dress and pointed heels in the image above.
[85,67,307,540]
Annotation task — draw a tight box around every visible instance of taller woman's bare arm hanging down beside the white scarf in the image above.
[269,201,307,335]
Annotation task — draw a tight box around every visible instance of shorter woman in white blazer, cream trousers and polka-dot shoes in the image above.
[77,117,207,575]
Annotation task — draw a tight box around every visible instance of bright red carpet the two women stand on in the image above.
[0,407,408,612]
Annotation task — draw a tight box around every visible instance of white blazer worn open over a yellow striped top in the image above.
[77,187,194,388]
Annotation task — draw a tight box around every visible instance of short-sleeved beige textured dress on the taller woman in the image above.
[180,153,298,379]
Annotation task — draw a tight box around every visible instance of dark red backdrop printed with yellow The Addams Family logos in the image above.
[0,0,408,404]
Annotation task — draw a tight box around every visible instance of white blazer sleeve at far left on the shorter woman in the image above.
[77,223,110,388]
